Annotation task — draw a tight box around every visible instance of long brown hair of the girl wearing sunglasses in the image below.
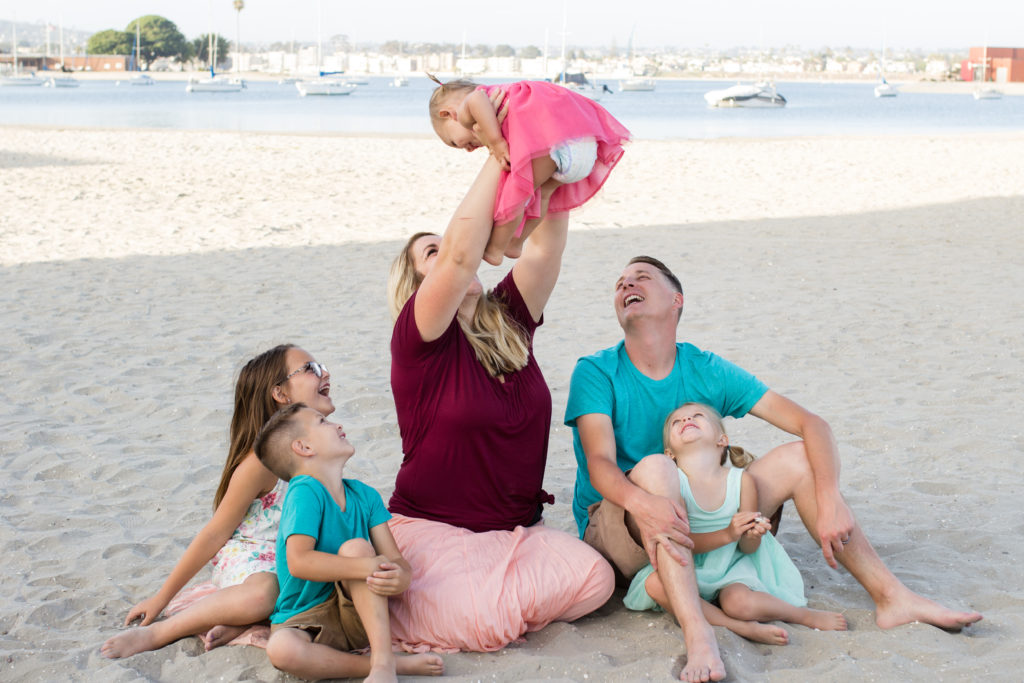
[213,344,295,510]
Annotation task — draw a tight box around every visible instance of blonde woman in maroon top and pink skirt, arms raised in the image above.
[388,159,614,651]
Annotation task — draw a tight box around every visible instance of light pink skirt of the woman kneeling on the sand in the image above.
[388,515,614,652]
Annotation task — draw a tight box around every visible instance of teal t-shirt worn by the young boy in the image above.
[270,475,391,624]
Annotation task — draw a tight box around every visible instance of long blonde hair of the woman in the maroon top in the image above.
[387,232,529,377]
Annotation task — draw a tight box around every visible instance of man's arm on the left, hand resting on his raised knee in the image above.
[575,413,693,568]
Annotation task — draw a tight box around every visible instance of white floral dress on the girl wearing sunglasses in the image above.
[212,479,288,588]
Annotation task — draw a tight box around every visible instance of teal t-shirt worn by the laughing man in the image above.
[565,341,768,538]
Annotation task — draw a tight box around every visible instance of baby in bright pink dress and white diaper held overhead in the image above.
[428,74,630,265]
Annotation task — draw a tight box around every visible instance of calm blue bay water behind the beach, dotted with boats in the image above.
[0,78,1024,139]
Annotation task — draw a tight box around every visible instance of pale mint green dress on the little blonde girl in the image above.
[623,467,807,610]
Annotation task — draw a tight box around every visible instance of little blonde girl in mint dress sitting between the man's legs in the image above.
[624,403,847,631]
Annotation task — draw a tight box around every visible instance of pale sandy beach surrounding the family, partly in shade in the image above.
[0,128,1024,683]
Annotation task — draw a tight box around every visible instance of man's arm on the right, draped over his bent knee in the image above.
[751,391,854,568]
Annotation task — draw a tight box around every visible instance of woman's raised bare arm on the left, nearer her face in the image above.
[414,158,501,341]
